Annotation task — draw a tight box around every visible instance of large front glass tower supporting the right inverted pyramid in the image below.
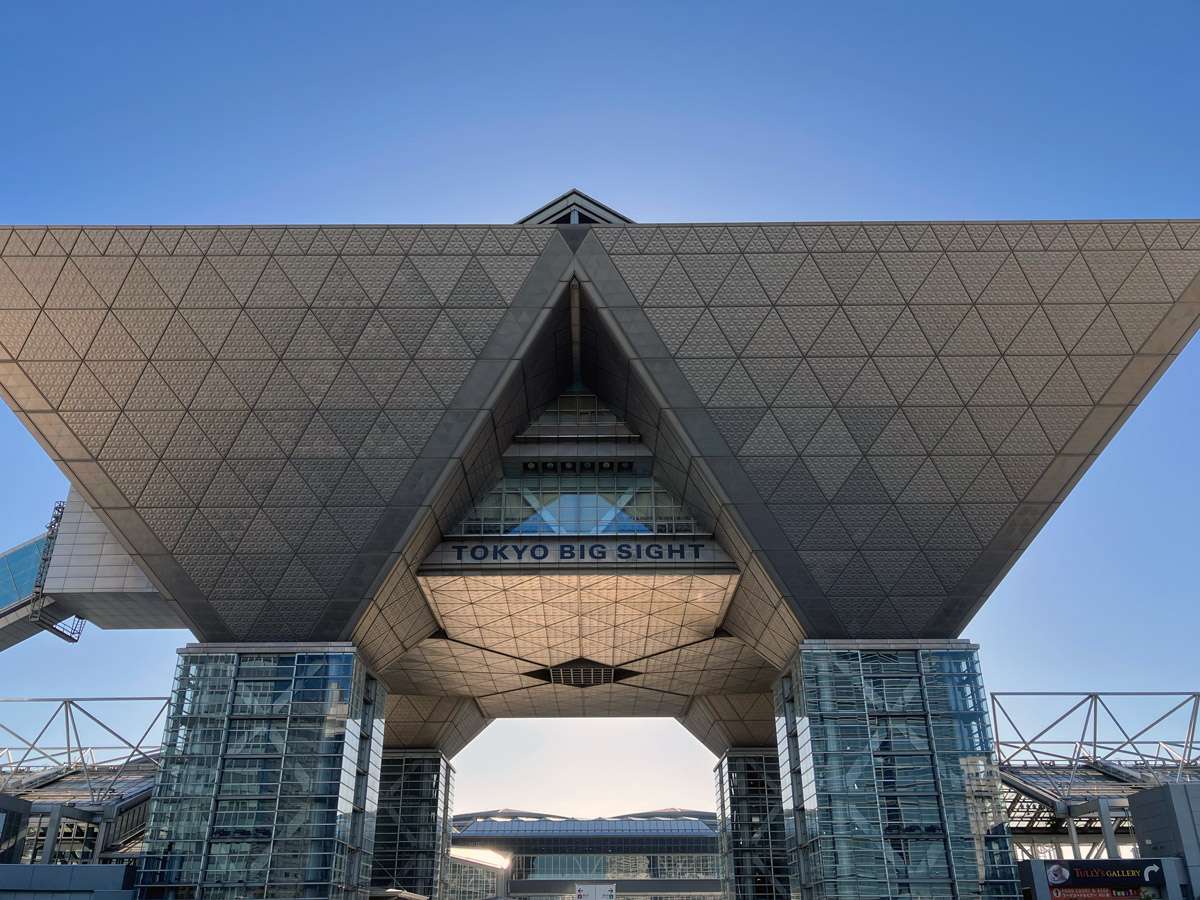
[775,641,1020,900]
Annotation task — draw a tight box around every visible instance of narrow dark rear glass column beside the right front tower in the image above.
[714,748,791,900]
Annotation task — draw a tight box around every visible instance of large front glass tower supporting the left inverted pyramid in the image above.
[139,643,386,900]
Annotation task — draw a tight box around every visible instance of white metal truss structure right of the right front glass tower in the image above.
[991,692,1200,858]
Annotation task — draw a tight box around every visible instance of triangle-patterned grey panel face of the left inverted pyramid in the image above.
[0,227,554,640]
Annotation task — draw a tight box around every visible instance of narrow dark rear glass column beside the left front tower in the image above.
[371,750,455,900]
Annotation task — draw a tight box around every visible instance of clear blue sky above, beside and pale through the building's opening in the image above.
[0,0,1200,814]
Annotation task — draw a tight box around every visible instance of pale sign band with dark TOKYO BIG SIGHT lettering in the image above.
[421,535,736,573]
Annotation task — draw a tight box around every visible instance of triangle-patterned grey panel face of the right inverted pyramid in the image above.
[578,222,1200,638]
